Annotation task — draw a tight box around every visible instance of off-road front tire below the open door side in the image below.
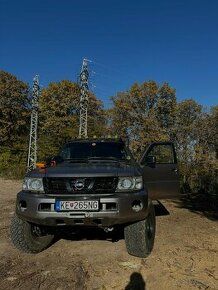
[124,203,156,258]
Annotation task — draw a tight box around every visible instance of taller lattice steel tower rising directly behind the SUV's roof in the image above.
[79,59,89,138]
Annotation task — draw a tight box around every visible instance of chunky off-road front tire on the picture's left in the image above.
[10,214,54,254]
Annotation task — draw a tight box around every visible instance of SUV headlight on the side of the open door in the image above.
[117,176,143,191]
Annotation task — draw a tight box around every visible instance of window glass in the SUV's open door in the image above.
[146,144,175,164]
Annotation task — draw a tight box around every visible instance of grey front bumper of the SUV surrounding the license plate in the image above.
[16,190,148,227]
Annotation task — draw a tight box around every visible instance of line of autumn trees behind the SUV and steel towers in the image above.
[0,71,218,194]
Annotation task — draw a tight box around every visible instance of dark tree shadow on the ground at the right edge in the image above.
[173,193,218,220]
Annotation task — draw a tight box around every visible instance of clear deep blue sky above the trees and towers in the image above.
[0,0,218,108]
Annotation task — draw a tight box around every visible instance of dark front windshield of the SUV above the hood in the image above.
[60,142,127,160]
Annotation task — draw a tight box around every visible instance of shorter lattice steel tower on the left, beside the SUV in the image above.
[27,75,39,171]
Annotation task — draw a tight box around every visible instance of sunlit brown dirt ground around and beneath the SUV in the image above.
[0,179,218,290]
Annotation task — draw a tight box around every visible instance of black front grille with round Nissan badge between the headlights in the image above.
[44,177,118,194]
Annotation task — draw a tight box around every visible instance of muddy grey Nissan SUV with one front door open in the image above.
[11,138,179,257]
